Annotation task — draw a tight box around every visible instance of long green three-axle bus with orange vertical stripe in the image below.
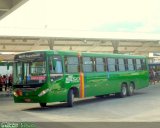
[13,50,149,107]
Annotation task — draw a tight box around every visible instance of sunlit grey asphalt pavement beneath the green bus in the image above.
[0,83,160,127]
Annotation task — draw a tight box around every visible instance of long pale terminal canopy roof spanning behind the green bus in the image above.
[0,30,160,56]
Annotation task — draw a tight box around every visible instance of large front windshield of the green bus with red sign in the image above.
[13,52,46,85]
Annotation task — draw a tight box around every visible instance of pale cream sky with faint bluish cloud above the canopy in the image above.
[0,0,160,34]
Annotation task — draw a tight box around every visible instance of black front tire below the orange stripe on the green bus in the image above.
[67,89,74,107]
